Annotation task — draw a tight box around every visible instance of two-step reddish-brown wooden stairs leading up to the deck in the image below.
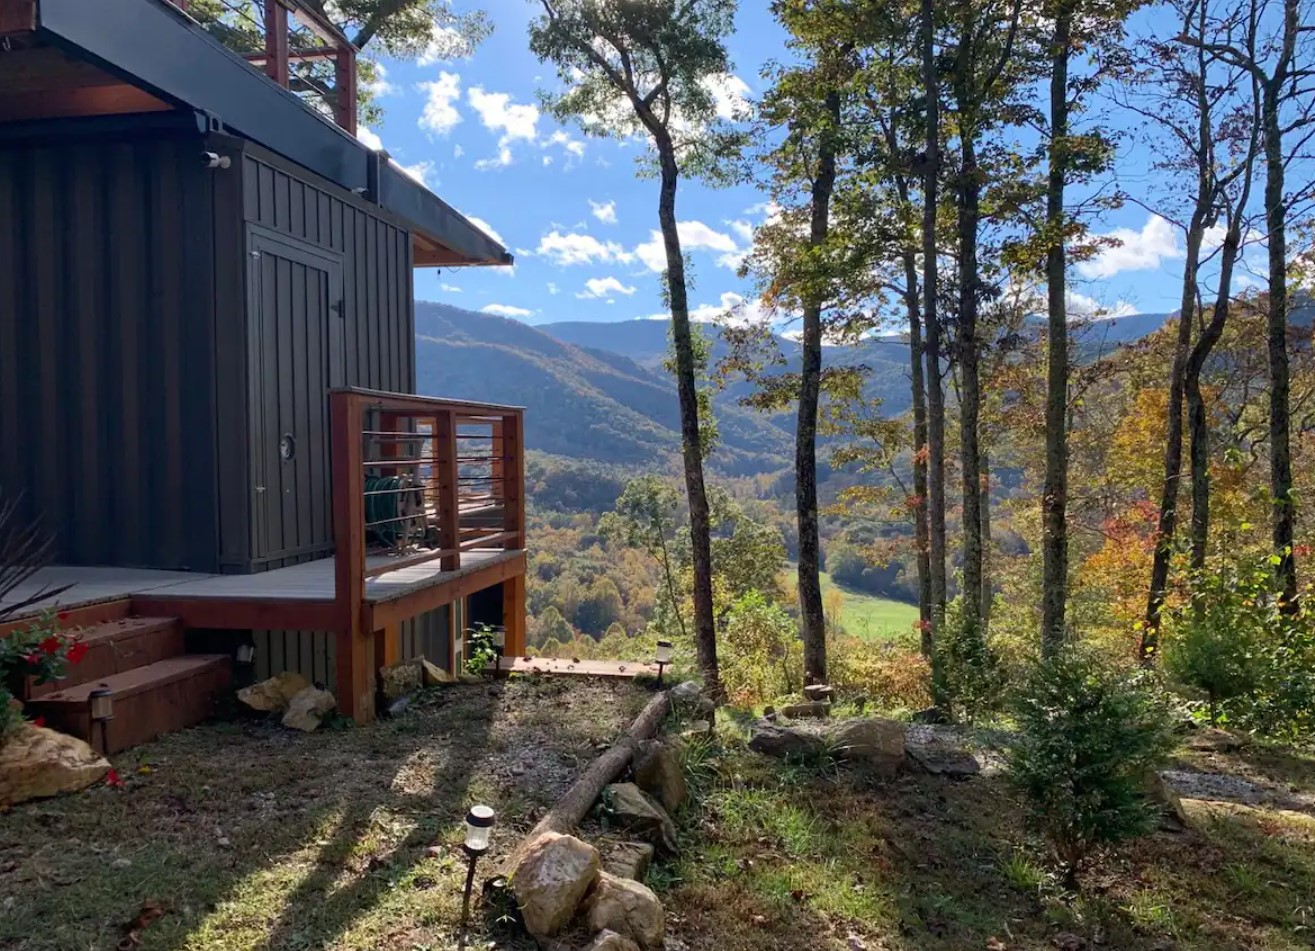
[24,617,233,754]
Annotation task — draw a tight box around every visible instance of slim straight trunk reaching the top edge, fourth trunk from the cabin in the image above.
[921,0,947,704]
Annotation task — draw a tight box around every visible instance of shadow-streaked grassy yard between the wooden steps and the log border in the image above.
[0,684,642,951]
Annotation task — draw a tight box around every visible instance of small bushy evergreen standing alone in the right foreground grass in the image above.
[1006,647,1173,885]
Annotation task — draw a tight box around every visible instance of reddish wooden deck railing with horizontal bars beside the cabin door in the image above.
[329,389,525,710]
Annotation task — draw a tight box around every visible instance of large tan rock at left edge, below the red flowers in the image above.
[0,723,109,810]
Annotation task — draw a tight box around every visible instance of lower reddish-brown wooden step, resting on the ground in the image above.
[26,654,233,752]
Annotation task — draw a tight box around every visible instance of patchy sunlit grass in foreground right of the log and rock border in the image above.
[655,748,1315,951]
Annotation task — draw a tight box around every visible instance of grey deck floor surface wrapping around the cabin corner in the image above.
[3,549,523,614]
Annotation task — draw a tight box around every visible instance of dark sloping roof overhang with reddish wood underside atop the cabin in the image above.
[0,0,512,267]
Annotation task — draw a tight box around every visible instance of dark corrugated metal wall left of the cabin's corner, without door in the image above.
[0,130,218,571]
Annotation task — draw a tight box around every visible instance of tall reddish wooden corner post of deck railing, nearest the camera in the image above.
[331,389,375,723]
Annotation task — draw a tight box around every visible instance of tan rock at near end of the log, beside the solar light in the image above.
[512,833,601,939]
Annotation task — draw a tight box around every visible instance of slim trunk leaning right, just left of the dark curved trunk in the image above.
[1140,214,1212,666]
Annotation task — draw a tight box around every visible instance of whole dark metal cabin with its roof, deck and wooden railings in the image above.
[0,0,525,735]
